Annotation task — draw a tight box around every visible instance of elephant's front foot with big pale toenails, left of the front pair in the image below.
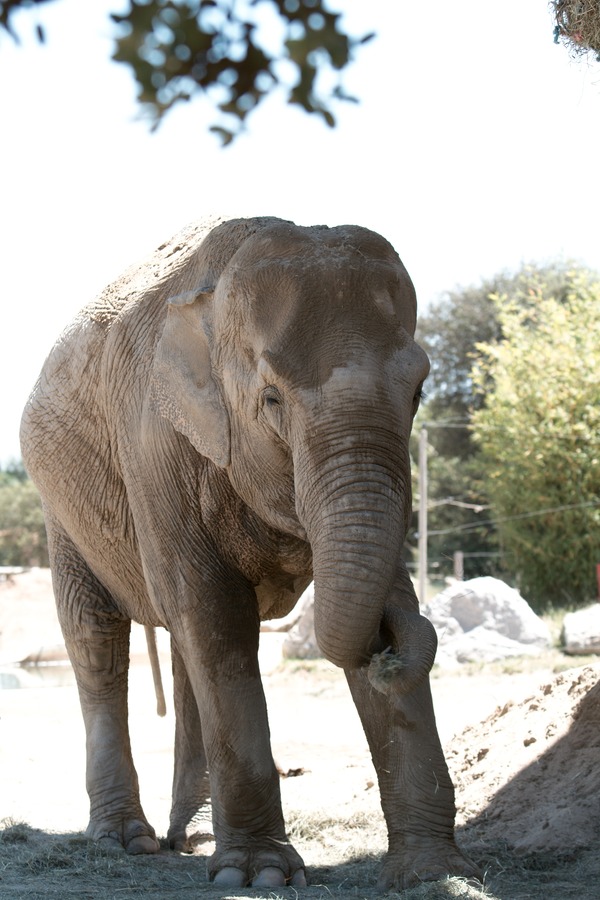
[208,841,306,888]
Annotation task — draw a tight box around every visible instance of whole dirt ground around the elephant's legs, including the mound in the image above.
[0,574,600,900]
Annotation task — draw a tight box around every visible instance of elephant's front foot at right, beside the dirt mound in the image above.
[377,840,483,891]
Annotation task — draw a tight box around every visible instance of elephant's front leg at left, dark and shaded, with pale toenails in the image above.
[174,588,306,887]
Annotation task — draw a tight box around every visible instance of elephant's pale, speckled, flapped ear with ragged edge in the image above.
[150,289,230,467]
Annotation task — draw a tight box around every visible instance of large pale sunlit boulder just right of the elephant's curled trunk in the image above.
[422,577,551,666]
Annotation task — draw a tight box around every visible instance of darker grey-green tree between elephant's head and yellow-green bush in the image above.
[412,262,591,581]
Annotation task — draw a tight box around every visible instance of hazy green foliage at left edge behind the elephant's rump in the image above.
[0,463,49,566]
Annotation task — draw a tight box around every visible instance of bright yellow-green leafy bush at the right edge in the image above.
[473,270,600,610]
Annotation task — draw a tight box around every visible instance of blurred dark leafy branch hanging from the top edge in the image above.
[0,0,372,143]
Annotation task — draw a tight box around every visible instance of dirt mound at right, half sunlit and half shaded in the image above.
[446,665,600,854]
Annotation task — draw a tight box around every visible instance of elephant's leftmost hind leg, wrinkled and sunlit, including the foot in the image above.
[49,524,158,853]
